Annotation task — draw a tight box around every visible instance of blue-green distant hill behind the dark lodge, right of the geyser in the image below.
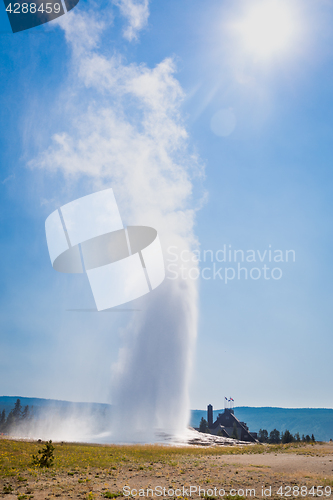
[191,406,333,441]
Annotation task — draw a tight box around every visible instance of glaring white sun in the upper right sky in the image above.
[235,0,297,58]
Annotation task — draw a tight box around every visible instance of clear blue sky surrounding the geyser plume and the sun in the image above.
[0,0,333,408]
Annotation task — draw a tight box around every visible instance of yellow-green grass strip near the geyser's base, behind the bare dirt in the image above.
[0,439,332,477]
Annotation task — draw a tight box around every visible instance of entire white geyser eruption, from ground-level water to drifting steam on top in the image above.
[31,0,201,440]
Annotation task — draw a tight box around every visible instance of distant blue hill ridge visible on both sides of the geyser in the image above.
[0,396,333,441]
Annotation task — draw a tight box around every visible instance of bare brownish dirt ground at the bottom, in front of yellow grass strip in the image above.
[0,443,333,500]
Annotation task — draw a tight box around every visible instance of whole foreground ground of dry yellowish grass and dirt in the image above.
[0,439,333,500]
